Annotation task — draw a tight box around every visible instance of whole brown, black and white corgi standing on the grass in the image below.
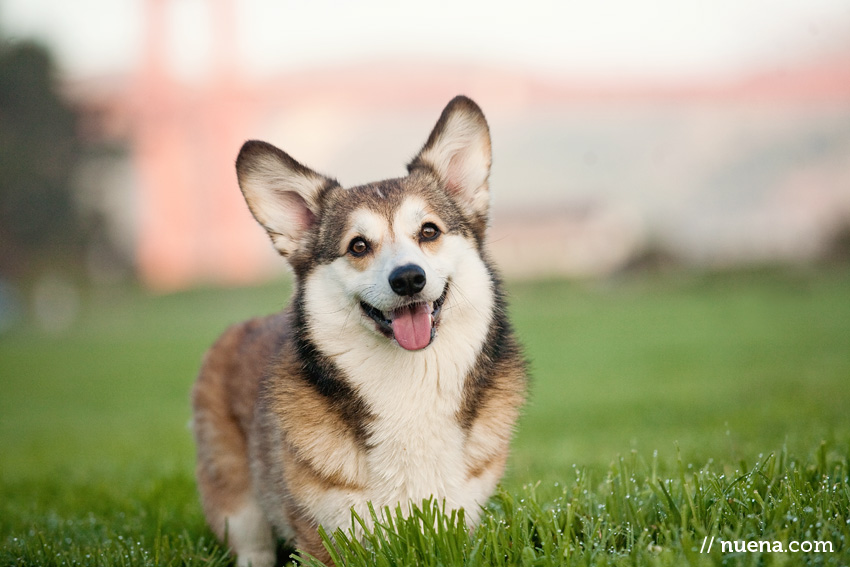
[192,96,527,567]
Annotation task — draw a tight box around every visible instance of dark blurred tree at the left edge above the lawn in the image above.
[0,41,84,277]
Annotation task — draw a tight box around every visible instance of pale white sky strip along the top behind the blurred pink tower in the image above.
[0,0,850,78]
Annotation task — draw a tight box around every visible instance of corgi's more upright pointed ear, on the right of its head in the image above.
[407,96,491,218]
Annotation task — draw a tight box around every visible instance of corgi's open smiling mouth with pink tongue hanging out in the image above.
[360,284,449,350]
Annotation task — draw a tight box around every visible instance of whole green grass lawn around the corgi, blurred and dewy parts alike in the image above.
[0,267,850,566]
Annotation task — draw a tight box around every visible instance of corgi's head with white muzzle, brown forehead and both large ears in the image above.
[236,97,493,356]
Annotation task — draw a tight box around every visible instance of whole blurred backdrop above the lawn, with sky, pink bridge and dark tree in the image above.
[0,0,850,312]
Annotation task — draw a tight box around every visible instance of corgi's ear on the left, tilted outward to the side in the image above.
[236,140,338,256]
